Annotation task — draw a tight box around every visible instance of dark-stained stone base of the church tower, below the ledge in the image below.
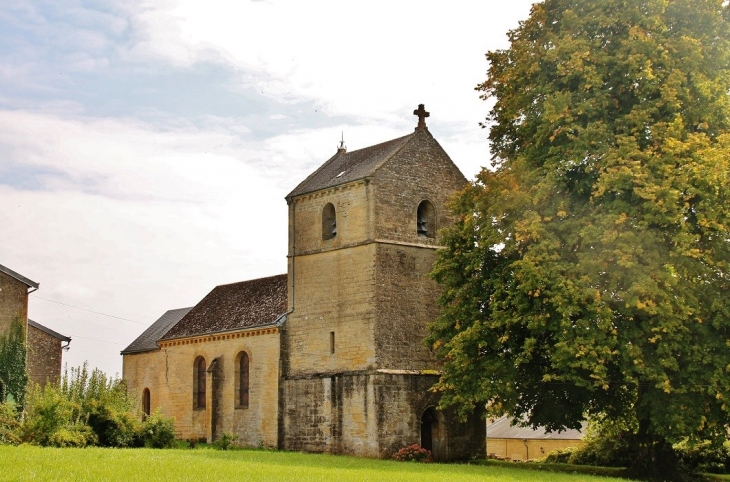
[280,370,485,461]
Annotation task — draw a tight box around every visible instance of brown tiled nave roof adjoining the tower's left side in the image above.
[161,274,287,340]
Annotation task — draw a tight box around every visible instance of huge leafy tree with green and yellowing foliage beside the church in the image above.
[428,0,730,480]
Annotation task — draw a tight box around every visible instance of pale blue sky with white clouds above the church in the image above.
[0,0,532,375]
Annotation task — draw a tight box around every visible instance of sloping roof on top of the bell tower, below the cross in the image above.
[287,134,415,198]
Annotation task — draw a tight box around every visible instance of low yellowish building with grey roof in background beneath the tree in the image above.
[487,417,583,460]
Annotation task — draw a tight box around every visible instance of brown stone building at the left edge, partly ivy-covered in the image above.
[0,265,71,387]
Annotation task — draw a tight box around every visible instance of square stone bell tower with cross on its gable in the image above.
[279,105,484,460]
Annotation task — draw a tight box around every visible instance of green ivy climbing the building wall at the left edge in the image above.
[0,316,28,406]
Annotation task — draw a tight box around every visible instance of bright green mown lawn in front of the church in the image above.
[0,445,619,482]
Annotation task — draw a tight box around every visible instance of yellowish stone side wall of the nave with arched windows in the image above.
[123,328,280,447]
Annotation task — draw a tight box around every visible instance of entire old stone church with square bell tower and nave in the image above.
[122,105,485,461]
